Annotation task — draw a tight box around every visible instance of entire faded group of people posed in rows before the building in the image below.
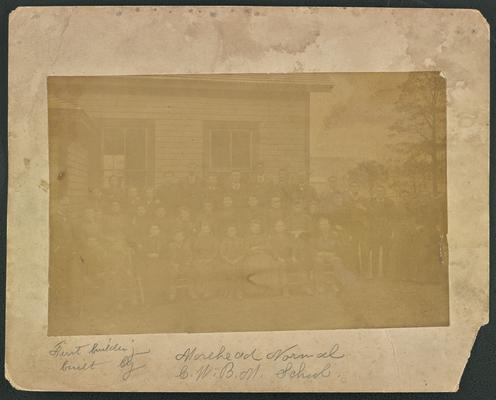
[51,170,447,305]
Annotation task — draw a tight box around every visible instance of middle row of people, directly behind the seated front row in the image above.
[75,196,336,244]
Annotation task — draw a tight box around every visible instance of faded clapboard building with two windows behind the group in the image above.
[48,74,332,208]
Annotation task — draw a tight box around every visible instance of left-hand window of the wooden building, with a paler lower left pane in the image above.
[102,120,154,187]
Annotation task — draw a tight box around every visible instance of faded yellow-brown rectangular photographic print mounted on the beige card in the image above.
[47,71,449,336]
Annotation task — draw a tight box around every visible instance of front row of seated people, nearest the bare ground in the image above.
[79,218,340,305]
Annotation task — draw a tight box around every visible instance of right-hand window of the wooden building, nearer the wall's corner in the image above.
[205,123,257,172]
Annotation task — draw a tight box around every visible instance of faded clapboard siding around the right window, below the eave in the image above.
[68,92,308,183]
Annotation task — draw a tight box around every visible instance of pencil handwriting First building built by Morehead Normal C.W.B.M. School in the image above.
[48,338,345,383]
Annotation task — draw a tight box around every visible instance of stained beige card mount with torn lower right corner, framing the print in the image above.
[6,7,489,392]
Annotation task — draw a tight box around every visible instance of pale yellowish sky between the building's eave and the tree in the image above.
[310,73,407,161]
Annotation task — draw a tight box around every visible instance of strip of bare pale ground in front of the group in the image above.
[50,279,449,335]
